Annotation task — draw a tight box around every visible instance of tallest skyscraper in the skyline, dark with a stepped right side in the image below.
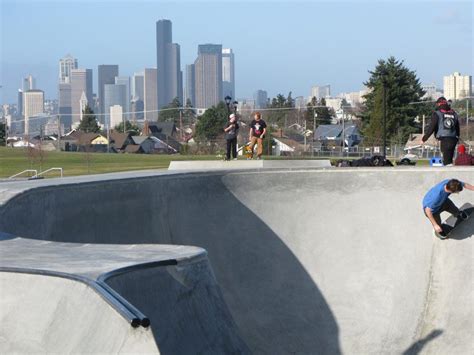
[156,20,183,108]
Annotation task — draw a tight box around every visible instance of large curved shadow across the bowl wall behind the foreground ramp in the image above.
[0,174,341,354]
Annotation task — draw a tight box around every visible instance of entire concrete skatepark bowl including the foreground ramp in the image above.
[0,165,474,354]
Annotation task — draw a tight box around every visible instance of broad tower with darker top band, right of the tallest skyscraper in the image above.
[194,44,222,108]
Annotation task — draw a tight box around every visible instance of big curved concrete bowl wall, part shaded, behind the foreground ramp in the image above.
[0,167,474,354]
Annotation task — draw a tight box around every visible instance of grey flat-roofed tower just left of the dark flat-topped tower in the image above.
[70,69,93,124]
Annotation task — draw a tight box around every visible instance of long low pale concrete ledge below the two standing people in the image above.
[168,160,331,170]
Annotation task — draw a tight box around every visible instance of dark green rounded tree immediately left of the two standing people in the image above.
[196,101,227,141]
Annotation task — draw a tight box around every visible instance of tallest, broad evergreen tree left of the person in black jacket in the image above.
[361,57,424,144]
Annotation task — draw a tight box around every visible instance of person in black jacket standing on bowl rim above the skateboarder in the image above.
[422,97,459,165]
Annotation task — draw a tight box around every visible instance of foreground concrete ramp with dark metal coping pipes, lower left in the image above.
[0,238,249,354]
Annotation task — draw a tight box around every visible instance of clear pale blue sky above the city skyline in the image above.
[0,0,474,103]
